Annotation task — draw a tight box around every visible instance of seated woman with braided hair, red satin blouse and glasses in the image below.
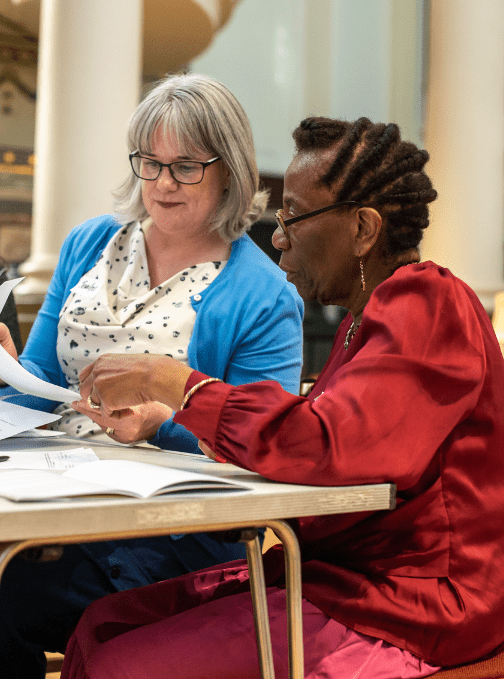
[62,118,504,679]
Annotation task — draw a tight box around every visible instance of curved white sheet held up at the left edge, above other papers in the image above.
[0,278,80,404]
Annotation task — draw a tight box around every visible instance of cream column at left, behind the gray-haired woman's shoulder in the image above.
[16,0,142,302]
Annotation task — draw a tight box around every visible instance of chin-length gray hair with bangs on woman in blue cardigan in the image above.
[114,73,268,241]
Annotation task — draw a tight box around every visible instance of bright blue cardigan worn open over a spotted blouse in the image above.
[7,215,303,452]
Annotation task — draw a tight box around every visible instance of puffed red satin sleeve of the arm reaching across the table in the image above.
[175,264,492,489]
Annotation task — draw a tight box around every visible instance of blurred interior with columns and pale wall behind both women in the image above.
[0,0,504,375]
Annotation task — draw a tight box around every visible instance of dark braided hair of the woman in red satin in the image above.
[292,117,437,255]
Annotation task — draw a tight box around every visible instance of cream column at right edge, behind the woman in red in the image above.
[422,0,504,312]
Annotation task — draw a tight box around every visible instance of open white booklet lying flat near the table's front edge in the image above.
[0,460,252,502]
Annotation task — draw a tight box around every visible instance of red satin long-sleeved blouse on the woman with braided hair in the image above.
[175,262,504,666]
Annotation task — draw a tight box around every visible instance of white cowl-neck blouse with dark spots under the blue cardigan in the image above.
[51,222,226,436]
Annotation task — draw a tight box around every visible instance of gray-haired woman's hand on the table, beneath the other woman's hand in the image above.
[73,400,173,443]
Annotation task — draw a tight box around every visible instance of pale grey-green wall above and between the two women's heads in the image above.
[191,0,424,174]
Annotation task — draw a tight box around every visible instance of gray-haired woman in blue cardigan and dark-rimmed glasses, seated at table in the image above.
[0,74,302,677]
